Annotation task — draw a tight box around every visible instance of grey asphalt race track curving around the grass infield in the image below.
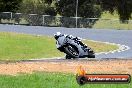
[0,24,132,59]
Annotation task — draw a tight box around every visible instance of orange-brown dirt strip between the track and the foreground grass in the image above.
[0,60,132,75]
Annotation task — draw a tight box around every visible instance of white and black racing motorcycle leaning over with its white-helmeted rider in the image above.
[54,32,95,59]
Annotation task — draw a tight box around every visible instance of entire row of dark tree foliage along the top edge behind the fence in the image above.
[0,0,132,24]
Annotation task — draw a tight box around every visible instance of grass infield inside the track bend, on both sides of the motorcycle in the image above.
[0,32,118,60]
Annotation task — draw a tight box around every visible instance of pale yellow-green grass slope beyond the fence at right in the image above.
[93,12,132,30]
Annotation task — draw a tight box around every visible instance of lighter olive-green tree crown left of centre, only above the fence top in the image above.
[20,0,56,15]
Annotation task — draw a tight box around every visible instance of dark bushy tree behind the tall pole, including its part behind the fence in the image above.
[56,0,101,27]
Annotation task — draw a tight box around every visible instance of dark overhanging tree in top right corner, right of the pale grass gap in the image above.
[100,0,132,23]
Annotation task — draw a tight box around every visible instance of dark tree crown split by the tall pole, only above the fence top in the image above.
[56,0,101,18]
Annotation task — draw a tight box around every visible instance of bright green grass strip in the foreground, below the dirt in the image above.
[0,72,132,88]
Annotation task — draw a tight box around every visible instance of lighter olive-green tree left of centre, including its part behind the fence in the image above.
[19,0,56,25]
